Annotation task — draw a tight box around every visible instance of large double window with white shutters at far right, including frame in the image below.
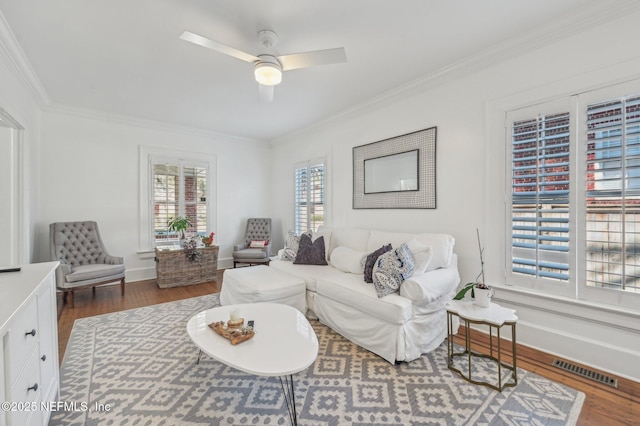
[506,83,640,307]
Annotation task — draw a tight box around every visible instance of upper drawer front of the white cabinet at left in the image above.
[5,297,40,384]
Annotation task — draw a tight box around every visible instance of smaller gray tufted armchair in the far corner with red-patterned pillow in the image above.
[233,218,271,268]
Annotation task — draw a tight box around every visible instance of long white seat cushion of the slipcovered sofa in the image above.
[317,273,413,324]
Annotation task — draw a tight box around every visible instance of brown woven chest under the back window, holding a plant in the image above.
[156,246,219,288]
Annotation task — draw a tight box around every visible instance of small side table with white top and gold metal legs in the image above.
[447,300,518,392]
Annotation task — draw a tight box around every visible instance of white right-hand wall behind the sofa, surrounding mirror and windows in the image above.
[272,13,640,380]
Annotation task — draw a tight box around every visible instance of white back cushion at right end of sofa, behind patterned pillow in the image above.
[367,231,455,271]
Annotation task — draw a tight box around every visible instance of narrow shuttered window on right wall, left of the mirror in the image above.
[294,160,325,234]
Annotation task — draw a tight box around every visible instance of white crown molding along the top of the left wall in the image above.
[0,11,51,107]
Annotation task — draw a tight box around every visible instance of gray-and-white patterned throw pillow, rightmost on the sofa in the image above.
[373,243,415,297]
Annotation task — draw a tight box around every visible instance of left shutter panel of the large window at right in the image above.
[510,112,571,281]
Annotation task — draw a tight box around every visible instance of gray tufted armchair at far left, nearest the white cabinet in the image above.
[49,221,125,308]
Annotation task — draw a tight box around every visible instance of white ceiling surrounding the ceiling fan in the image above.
[0,0,631,140]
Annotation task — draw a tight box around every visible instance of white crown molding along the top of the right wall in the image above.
[270,0,640,145]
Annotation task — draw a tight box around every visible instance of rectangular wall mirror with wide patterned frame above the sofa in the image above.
[353,127,437,209]
